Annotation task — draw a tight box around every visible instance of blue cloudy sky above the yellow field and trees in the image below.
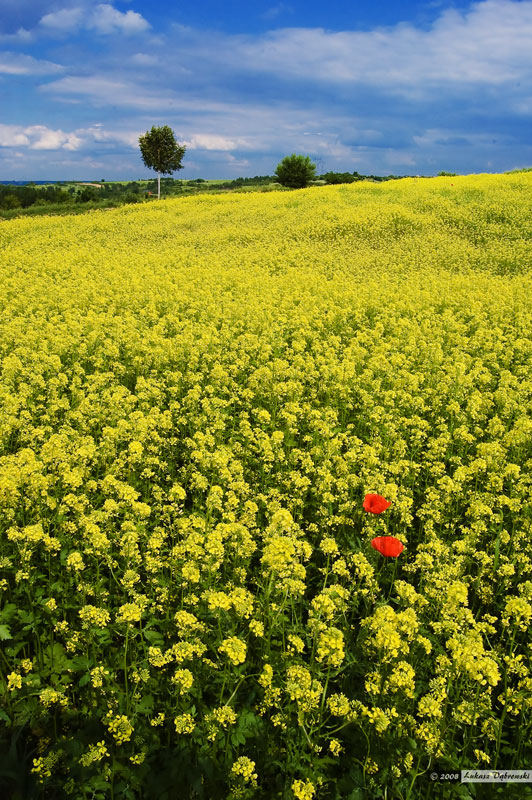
[0,0,532,180]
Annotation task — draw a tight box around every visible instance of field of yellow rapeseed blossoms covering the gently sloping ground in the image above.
[0,172,532,800]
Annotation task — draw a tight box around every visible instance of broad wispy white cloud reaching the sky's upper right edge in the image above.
[168,0,532,96]
